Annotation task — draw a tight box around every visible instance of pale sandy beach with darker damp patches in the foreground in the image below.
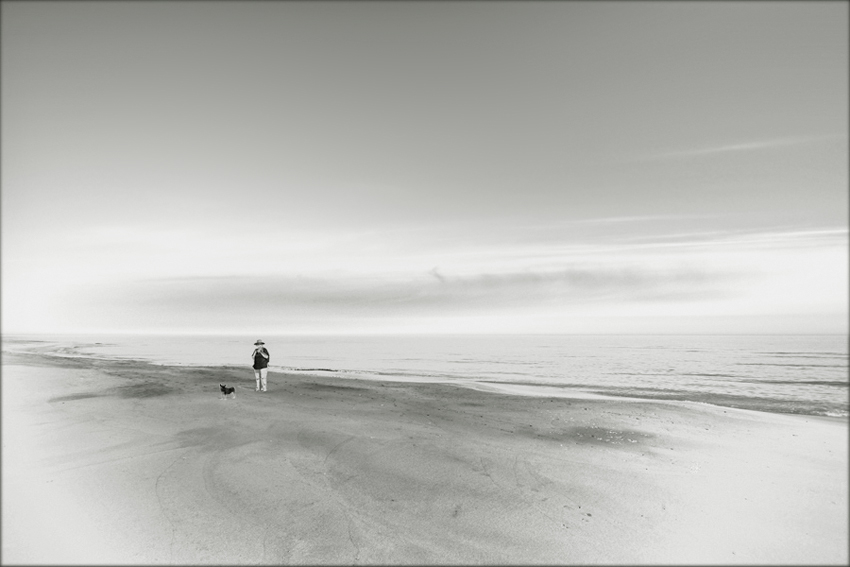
[2,353,848,565]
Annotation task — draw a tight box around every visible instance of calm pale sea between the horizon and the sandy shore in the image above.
[3,335,848,417]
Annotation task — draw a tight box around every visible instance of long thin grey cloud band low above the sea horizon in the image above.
[111,267,735,316]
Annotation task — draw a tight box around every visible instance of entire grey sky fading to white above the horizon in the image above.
[0,0,849,335]
